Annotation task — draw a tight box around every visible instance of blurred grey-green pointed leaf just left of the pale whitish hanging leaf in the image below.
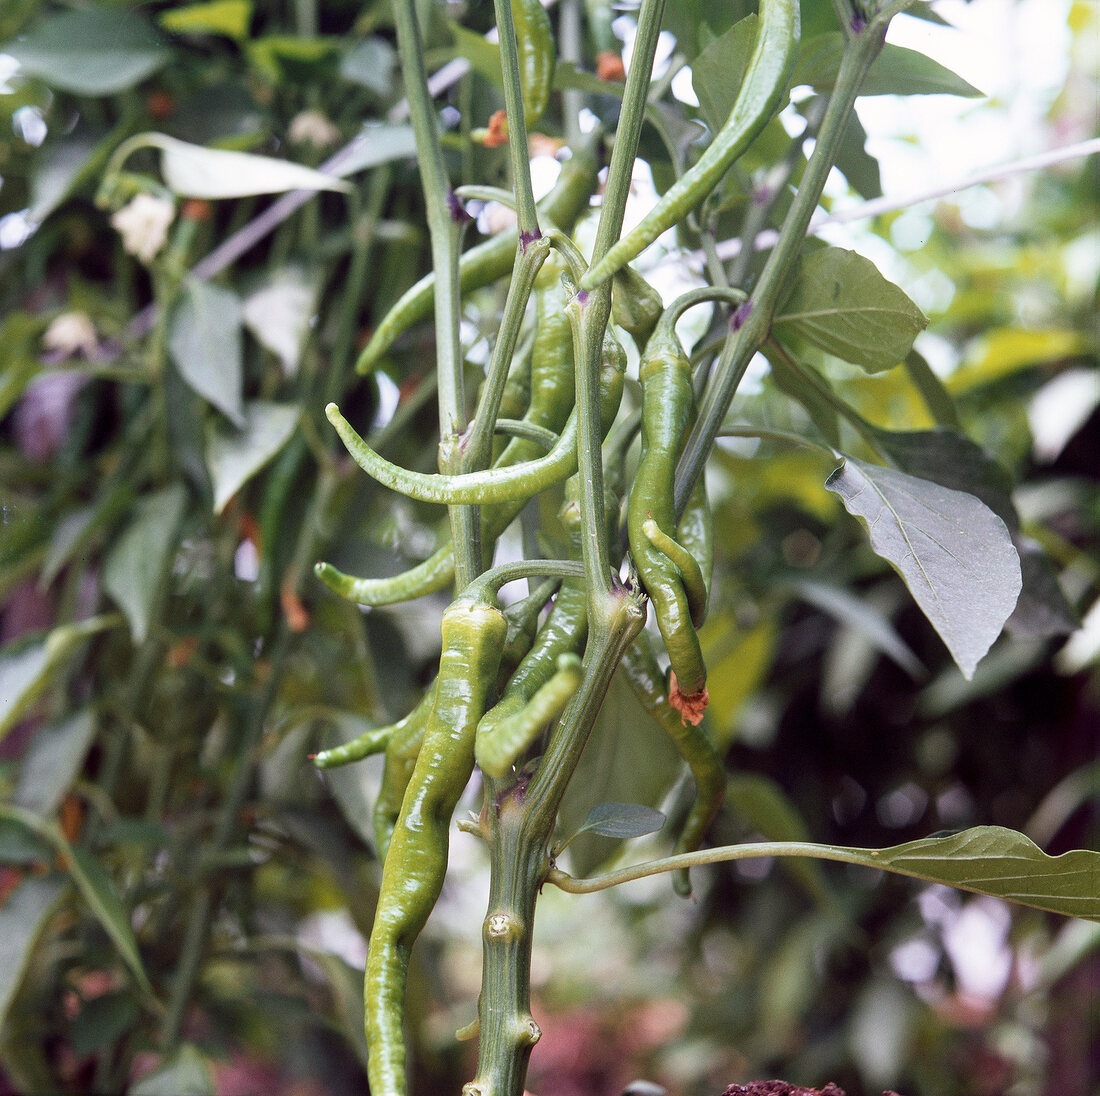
[168,278,244,426]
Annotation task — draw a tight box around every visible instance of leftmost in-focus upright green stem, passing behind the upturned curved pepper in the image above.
[393,0,482,589]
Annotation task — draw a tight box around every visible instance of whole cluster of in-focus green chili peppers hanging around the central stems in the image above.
[305,0,799,1096]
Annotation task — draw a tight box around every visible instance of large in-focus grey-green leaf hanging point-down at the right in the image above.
[825,457,1021,678]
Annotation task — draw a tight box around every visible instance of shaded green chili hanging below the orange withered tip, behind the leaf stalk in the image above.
[622,632,726,897]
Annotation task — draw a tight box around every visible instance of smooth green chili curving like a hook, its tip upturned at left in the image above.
[325,331,626,505]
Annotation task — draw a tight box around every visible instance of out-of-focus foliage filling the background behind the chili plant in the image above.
[0,0,1100,1096]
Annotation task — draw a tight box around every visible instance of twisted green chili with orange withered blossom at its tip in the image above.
[627,322,706,704]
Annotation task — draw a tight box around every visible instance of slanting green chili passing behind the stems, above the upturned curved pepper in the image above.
[355,149,598,373]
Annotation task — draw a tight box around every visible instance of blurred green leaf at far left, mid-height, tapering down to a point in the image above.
[102,483,187,644]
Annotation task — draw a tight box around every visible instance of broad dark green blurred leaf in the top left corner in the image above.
[2,6,174,96]
